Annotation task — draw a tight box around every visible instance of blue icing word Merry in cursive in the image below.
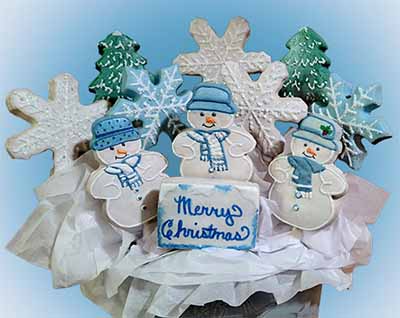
[174,195,243,226]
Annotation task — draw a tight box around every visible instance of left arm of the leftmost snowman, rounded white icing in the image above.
[86,167,121,199]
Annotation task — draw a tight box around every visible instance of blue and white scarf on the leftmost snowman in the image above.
[104,154,143,191]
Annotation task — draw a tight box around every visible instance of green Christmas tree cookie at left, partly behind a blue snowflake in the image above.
[89,31,147,104]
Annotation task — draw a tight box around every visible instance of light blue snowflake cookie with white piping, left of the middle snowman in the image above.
[108,65,192,148]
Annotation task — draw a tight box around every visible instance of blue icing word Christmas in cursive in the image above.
[159,219,251,242]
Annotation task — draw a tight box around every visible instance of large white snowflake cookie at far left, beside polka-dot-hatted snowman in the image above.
[6,73,107,173]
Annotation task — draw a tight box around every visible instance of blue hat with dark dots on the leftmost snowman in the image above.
[90,116,140,151]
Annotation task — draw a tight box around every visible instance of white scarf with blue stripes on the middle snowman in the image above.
[188,129,230,173]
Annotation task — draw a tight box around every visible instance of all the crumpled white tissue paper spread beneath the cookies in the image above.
[8,152,388,318]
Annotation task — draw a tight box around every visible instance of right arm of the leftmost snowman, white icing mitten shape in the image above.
[137,151,168,181]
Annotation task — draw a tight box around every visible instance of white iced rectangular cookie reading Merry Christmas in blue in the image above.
[158,177,260,250]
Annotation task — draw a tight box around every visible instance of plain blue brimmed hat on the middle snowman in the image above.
[186,83,237,114]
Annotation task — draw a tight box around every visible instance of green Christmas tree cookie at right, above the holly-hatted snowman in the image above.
[280,27,331,105]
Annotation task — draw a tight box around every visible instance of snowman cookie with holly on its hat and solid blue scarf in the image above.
[268,115,347,230]
